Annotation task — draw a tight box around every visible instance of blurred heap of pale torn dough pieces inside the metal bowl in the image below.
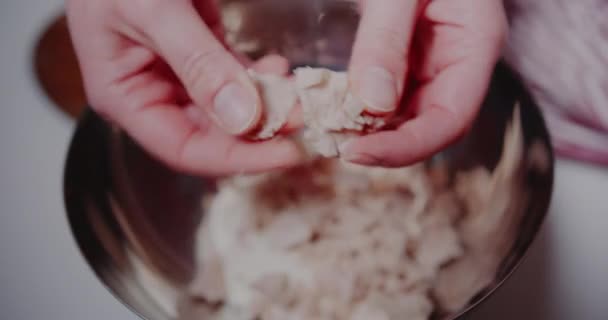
[191,108,536,320]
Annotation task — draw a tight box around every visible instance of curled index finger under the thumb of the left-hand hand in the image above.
[118,104,300,176]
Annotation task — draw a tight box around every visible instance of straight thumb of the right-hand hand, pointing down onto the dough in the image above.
[350,0,419,114]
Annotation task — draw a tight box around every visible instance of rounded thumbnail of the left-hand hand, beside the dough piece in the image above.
[213,82,257,134]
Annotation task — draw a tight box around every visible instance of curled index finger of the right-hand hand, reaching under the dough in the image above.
[342,0,506,166]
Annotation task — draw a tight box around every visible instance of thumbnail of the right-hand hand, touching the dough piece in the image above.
[359,67,399,112]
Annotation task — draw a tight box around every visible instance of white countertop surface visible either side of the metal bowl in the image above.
[0,0,608,320]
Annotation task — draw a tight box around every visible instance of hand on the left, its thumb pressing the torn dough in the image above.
[67,0,299,175]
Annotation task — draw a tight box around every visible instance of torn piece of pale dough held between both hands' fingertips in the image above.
[250,68,386,157]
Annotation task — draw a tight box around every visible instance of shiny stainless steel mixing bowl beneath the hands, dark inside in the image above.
[64,0,553,320]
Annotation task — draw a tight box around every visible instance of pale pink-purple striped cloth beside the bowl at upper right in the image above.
[505,0,608,165]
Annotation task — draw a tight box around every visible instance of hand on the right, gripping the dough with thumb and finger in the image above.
[341,0,507,167]
